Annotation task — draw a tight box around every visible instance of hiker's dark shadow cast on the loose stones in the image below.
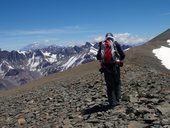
[81,104,112,115]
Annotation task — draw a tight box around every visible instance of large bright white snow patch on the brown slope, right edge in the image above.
[152,46,170,70]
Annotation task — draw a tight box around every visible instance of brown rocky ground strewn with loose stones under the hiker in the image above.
[0,62,170,128]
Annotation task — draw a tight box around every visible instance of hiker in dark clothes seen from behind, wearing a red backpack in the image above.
[97,33,125,107]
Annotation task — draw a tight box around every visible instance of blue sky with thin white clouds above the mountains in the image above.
[0,0,170,50]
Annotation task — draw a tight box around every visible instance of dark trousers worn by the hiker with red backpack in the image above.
[104,65,121,105]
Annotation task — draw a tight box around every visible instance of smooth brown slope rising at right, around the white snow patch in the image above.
[126,29,170,72]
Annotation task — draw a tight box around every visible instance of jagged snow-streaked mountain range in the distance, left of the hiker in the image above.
[0,42,130,89]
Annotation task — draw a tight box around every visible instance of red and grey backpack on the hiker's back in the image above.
[99,40,119,63]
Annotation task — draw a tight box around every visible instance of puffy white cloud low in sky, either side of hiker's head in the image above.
[94,33,148,45]
